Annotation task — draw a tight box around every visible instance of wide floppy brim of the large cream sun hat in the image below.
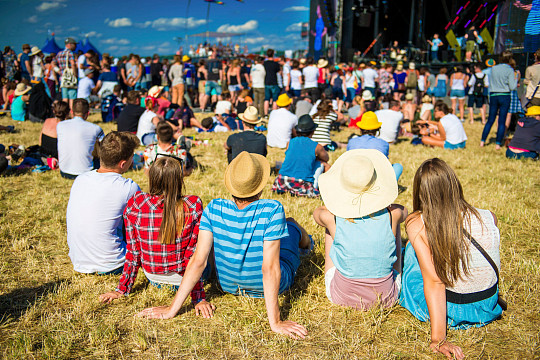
[319,149,398,219]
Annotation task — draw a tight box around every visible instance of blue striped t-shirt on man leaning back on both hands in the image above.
[199,199,289,297]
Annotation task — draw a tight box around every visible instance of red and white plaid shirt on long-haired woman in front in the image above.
[116,192,205,303]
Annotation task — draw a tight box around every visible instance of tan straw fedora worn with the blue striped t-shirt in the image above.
[225,151,272,199]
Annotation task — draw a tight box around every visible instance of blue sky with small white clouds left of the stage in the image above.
[0,0,309,55]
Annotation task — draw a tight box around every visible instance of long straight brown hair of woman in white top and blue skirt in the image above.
[409,158,481,287]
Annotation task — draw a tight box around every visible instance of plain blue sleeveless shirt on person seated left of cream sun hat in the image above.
[279,136,318,182]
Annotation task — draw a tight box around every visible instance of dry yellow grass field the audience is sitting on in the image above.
[0,111,540,359]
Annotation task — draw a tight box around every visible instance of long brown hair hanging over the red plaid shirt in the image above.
[148,157,186,244]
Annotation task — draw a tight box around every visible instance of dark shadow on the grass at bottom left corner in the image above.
[0,280,70,324]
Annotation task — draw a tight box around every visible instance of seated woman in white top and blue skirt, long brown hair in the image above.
[400,158,505,359]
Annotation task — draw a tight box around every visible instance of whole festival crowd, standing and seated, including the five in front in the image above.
[0,38,540,358]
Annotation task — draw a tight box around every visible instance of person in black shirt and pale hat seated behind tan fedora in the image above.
[223,106,268,164]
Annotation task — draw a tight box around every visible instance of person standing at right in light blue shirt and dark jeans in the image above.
[480,51,517,150]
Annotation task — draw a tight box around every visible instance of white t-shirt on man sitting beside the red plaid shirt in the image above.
[66,171,140,273]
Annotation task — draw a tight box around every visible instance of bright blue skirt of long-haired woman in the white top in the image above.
[399,242,502,329]
